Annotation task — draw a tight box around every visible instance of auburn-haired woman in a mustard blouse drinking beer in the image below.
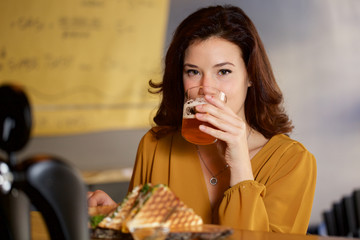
[89,6,316,234]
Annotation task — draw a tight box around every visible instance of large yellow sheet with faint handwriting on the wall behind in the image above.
[0,0,169,136]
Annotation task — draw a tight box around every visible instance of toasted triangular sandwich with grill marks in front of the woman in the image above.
[90,184,203,233]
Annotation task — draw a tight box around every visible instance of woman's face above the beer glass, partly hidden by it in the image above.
[183,37,250,119]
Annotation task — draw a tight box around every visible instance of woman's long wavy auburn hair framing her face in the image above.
[149,5,293,138]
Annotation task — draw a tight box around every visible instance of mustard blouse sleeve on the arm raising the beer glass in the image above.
[218,143,316,234]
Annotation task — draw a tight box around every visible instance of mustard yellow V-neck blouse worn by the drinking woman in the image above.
[129,127,316,234]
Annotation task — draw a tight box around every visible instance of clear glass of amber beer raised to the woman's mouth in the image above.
[181,86,226,145]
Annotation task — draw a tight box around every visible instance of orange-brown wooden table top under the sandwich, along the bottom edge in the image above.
[30,212,349,240]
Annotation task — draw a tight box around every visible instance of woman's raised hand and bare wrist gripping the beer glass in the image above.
[196,95,254,186]
